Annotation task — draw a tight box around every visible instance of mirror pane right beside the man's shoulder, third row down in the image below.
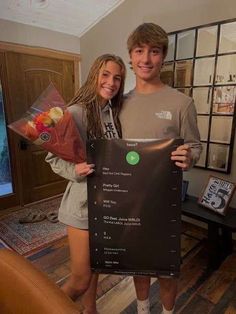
[193,87,211,113]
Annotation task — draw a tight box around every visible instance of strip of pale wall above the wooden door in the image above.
[0,19,80,54]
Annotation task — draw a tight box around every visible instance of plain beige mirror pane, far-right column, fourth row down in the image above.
[210,116,233,144]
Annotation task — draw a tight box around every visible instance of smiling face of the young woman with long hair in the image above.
[98,61,122,103]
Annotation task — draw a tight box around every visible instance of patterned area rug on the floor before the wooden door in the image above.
[0,198,66,255]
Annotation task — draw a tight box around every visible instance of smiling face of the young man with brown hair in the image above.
[130,44,164,83]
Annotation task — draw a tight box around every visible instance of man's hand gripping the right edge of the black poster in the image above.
[171,144,192,170]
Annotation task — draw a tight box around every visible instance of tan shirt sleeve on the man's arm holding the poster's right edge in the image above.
[181,100,202,166]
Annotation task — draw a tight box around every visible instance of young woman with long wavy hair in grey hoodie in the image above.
[46,54,126,314]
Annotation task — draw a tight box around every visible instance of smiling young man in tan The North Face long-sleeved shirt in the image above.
[120,23,201,314]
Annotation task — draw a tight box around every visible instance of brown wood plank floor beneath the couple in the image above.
[25,223,236,314]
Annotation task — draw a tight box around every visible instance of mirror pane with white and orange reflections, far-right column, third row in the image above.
[212,86,236,114]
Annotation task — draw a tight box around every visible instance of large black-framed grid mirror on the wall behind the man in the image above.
[166,18,236,173]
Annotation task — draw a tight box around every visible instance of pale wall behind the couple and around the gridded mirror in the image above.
[80,0,236,206]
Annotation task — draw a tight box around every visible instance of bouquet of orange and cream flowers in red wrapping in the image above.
[8,83,86,163]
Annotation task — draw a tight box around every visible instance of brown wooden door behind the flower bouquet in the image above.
[6,52,74,205]
